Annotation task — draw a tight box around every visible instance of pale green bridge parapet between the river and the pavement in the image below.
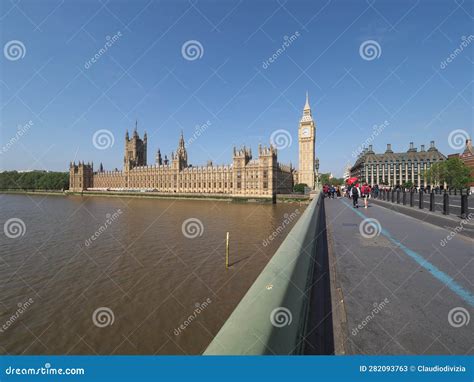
[204,192,325,355]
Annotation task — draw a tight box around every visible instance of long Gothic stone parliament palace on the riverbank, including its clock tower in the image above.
[69,95,315,197]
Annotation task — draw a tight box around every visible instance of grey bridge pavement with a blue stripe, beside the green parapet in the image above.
[325,198,474,354]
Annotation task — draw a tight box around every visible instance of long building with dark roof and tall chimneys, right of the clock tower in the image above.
[351,141,446,187]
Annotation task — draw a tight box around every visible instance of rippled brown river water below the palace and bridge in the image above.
[0,194,305,354]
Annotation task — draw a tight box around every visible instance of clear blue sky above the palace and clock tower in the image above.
[0,0,474,176]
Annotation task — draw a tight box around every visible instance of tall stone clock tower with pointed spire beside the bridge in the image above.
[298,92,316,188]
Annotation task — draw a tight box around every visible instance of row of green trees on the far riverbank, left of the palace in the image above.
[0,171,69,190]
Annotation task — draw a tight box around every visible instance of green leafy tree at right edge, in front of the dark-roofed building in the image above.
[424,158,471,188]
